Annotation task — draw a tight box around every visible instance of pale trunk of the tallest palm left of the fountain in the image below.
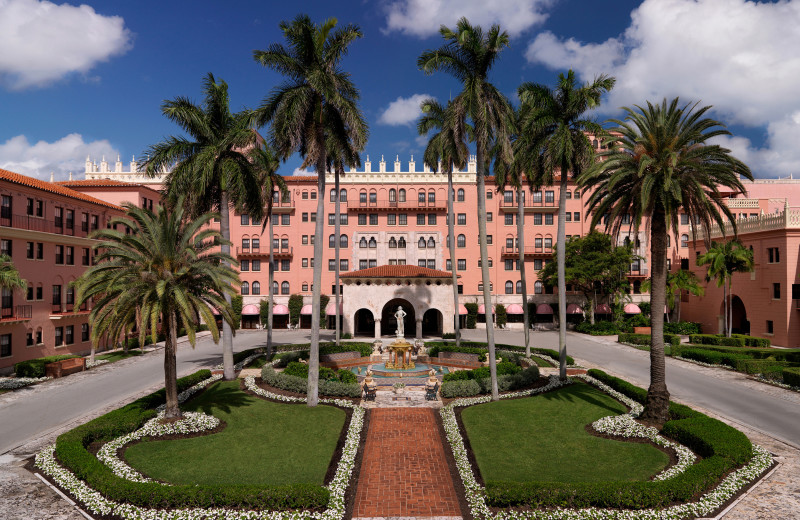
[308,150,328,406]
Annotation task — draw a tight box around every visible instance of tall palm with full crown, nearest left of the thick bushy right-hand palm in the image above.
[517,70,615,379]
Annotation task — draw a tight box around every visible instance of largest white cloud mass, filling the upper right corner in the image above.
[526,0,800,175]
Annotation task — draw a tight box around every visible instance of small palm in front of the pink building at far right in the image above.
[697,240,753,338]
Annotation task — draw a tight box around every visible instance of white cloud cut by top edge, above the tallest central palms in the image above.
[384,0,555,38]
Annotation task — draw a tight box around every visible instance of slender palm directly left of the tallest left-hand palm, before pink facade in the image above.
[250,145,289,355]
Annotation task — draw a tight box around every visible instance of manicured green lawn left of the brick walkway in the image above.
[125,381,346,485]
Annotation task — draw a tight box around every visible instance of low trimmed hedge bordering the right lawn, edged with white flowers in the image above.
[486,370,752,509]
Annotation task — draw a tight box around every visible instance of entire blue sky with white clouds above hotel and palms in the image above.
[0,0,800,179]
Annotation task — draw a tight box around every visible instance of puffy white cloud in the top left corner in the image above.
[0,0,131,89]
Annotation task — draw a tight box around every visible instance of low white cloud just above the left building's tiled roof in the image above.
[0,134,119,180]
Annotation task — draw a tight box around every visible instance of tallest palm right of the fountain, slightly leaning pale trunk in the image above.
[417,18,513,401]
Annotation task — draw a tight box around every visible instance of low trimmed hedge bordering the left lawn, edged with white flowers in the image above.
[56,370,330,510]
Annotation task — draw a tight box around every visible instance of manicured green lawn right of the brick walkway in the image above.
[461,383,669,482]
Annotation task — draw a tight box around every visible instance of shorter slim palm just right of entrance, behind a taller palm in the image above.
[417,99,471,347]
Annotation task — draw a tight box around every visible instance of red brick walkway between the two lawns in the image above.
[353,408,461,518]
